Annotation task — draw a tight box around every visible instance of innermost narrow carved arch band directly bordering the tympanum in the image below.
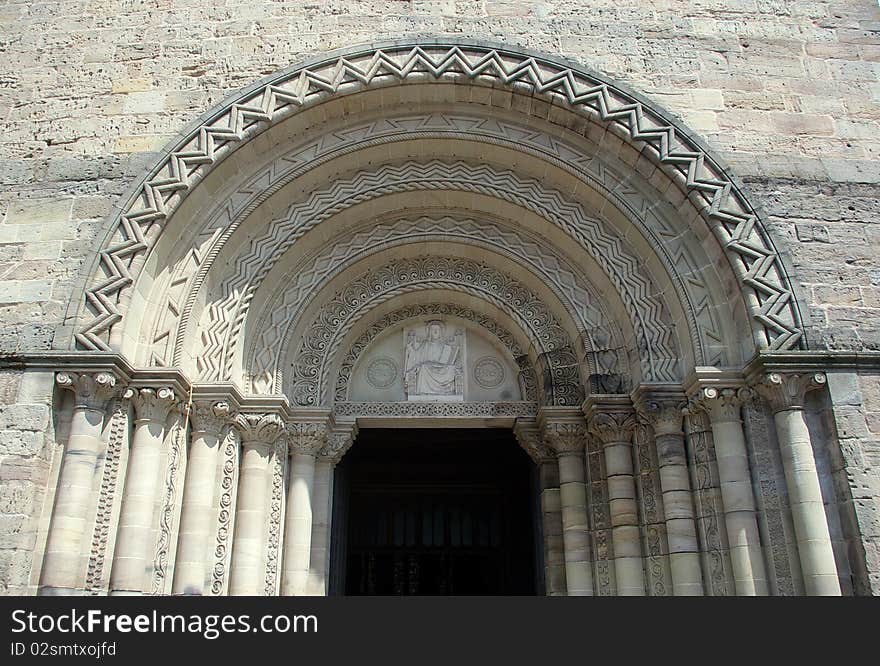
[328,302,539,403]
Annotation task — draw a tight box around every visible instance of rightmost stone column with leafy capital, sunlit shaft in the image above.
[757,372,840,596]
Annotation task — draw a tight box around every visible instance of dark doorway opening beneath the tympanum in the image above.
[332,429,538,595]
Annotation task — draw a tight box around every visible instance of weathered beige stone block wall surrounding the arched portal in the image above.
[0,0,880,592]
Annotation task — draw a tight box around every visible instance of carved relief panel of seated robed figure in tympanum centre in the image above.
[404,319,464,400]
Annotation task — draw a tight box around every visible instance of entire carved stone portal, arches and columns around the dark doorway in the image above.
[38,36,852,594]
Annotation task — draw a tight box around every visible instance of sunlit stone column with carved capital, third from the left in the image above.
[171,401,233,595]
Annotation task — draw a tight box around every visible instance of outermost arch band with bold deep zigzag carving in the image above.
[74,39,804,350]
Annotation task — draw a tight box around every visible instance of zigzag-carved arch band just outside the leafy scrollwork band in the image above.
[244,215,635,393]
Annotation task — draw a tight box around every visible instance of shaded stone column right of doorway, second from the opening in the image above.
[541,414,593,596]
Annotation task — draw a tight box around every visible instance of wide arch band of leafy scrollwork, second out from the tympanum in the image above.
[281,255,584,407]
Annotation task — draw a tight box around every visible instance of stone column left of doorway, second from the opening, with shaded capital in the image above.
[281,421,329,596]
